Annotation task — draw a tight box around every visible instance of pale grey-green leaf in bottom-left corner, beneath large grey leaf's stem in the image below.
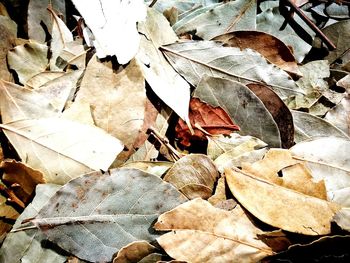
[0,184,66,263]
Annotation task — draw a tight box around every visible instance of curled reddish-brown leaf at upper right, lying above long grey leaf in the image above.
[213,30,301,75]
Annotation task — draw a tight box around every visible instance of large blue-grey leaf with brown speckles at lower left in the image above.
[32,169,186,262]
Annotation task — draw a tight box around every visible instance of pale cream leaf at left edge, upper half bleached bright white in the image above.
[0,118,123,184]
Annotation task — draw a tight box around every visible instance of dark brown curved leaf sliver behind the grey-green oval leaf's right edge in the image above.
[247,83,294,149]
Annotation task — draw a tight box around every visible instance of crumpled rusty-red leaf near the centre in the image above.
[175,98,239,147]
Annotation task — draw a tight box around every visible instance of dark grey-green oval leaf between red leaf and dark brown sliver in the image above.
[194,76,281,147]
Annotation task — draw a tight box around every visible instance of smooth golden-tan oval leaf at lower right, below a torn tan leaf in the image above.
[225,168,340,235]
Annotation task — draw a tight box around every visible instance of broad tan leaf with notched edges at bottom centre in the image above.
[154,199,273,263]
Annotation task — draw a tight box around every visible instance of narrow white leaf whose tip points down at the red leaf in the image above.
[136,9,190,125]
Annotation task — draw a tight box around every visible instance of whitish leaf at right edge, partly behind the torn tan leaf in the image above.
[290,137,350,207]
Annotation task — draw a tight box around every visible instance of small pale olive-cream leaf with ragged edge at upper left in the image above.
[7,41,48,84]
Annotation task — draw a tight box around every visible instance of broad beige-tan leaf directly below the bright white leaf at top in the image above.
[76,56,146,162]
